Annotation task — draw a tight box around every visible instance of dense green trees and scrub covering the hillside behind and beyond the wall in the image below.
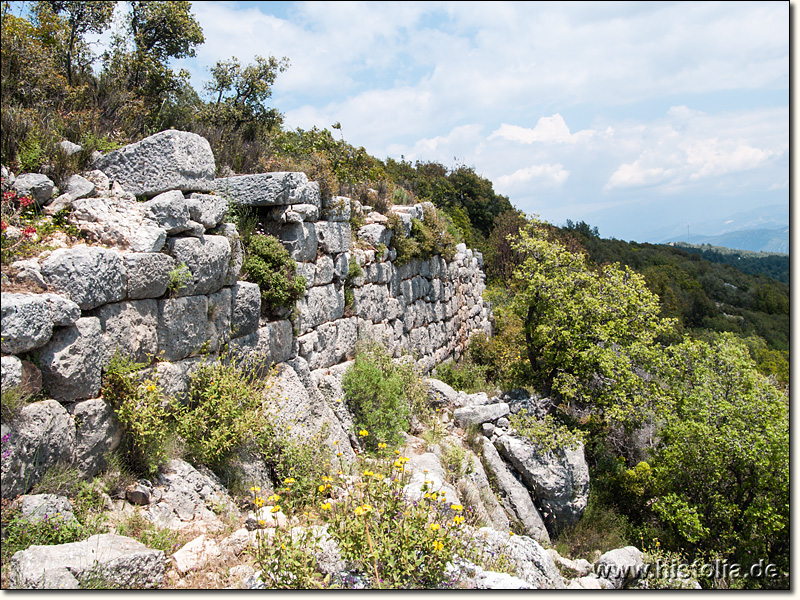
[0,1,789,586]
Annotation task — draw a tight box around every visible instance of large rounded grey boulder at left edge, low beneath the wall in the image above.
[0,400,75,498]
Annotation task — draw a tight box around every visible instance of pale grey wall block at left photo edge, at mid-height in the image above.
[0,292,53,354]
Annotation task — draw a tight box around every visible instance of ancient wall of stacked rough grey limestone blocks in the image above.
[2,131,490,497]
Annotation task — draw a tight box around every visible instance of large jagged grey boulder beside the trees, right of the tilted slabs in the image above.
[496,435,589,534]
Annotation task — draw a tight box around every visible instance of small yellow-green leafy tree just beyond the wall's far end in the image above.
[512,219,673,421]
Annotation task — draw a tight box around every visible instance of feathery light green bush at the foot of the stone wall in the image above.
[342,345,410,450]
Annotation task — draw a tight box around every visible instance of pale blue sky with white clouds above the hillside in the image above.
[104,1,789,241]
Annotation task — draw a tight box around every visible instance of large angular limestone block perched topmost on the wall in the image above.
[95,129,216,197]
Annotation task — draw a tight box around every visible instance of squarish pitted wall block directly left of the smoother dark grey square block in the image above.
[92,300,158,367]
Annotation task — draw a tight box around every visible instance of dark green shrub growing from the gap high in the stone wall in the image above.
[244,234,306,313]
